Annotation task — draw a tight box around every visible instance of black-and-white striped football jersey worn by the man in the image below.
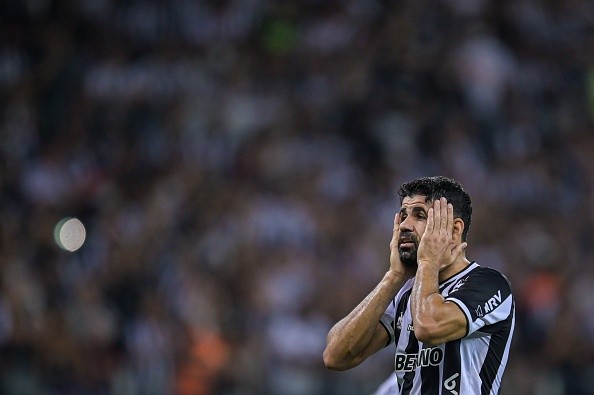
[381,262,515,395]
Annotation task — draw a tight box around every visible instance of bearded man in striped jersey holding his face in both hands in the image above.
[324,177,515,395]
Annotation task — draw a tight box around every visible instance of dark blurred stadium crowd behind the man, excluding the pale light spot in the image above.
[0,0,594,395]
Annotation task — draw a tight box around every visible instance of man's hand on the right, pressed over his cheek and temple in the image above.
[417,197,467,271]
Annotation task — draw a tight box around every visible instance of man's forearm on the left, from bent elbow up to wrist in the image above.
[324,271,405,370]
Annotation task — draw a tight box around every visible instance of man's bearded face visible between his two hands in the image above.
[398,195,431,268]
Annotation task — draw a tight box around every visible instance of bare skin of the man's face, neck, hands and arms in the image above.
[323,195,469,370]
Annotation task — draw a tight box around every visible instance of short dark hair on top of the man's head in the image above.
[398,176,472,241]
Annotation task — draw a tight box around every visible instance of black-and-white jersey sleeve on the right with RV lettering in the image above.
[446,268,513,337]
